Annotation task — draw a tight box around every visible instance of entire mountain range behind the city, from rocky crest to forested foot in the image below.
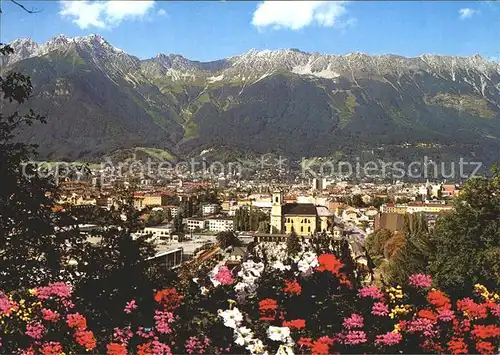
[2,35,500,165]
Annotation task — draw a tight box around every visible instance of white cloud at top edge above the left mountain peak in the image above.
[59,0,155,29]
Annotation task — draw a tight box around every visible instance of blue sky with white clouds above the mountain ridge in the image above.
[0,1,500,61]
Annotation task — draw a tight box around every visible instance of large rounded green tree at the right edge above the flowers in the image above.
[429,170,500,295]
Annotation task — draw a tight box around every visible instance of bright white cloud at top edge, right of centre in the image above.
[252,1,354,30]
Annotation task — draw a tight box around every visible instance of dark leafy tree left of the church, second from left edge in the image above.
[70,186,159,329]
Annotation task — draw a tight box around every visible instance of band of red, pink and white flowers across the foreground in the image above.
[0,251,500,355]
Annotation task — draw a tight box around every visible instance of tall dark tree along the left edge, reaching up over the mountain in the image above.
[0,44,82,291]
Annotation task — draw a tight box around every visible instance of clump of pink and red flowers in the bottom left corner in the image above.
[0,282,96,355]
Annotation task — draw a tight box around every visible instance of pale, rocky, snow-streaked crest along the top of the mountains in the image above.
[3,35,500,96]
